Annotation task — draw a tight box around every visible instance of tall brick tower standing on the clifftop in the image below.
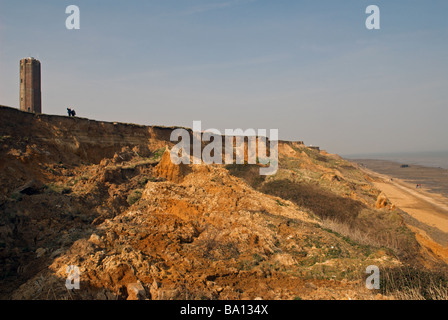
[20,58,42,113]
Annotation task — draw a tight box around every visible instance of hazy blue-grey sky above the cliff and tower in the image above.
[0,0,448,155]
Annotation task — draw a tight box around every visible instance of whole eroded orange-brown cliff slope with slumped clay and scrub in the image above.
[0,108,440,299]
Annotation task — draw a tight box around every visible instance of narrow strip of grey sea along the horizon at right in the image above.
[341,151,448,169]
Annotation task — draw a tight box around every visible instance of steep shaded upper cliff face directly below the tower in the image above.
[0,106,177,164]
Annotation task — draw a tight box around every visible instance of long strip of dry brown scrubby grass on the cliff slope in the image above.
[260,179,418,259]
